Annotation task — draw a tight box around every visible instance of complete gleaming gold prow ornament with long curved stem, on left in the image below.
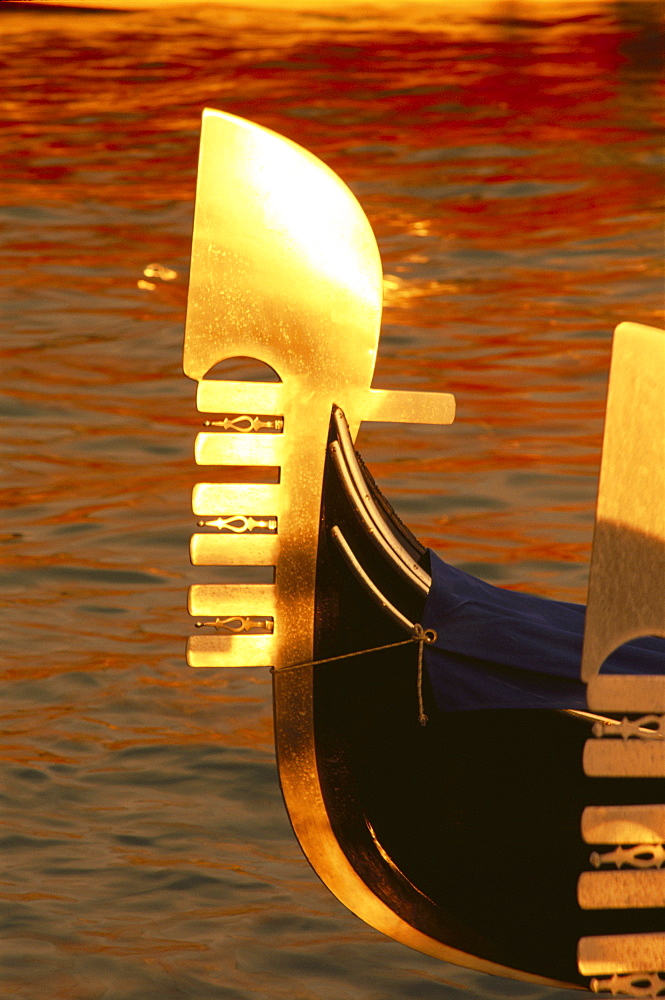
[184,110,572,985]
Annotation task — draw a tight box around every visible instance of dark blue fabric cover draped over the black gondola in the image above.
[422,551,665,712]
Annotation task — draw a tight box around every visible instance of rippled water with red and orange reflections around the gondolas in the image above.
[0,0,663,1000]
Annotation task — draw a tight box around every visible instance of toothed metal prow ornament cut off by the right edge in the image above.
[577,323,665,997]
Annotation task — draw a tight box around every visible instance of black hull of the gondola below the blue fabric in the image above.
[304,410,662,986]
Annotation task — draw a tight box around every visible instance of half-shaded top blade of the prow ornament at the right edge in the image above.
[582,323,665,684]
